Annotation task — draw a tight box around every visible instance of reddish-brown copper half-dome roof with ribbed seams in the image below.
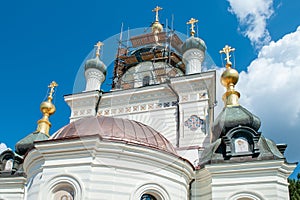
[50,116,177,155]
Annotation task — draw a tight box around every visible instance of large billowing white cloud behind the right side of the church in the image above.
[218,26,300,161]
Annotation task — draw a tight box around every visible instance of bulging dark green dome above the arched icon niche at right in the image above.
[212,105,261,142]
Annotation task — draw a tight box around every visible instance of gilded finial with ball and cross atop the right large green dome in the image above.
[220,45,240,106]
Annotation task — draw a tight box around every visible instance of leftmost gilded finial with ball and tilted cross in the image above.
[37,81,58,137]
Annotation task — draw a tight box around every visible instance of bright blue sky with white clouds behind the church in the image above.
[0,0,300,178]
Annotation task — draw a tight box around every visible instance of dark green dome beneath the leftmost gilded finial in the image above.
[15,131,48,156]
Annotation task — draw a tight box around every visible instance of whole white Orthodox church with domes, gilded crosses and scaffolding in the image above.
[0,6,295,200]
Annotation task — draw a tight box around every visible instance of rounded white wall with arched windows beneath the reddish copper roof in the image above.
[24,137,194,200]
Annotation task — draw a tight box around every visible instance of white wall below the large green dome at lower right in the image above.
[192,160,294,200]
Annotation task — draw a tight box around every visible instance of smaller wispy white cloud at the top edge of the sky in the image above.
[228,0,274,49]
